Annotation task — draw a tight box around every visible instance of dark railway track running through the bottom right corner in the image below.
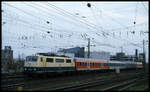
[79,75,148,91]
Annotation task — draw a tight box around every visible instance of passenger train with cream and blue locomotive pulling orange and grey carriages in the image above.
[24,55,143,74]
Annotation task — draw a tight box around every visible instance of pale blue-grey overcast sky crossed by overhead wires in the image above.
[2,1,149,61]
